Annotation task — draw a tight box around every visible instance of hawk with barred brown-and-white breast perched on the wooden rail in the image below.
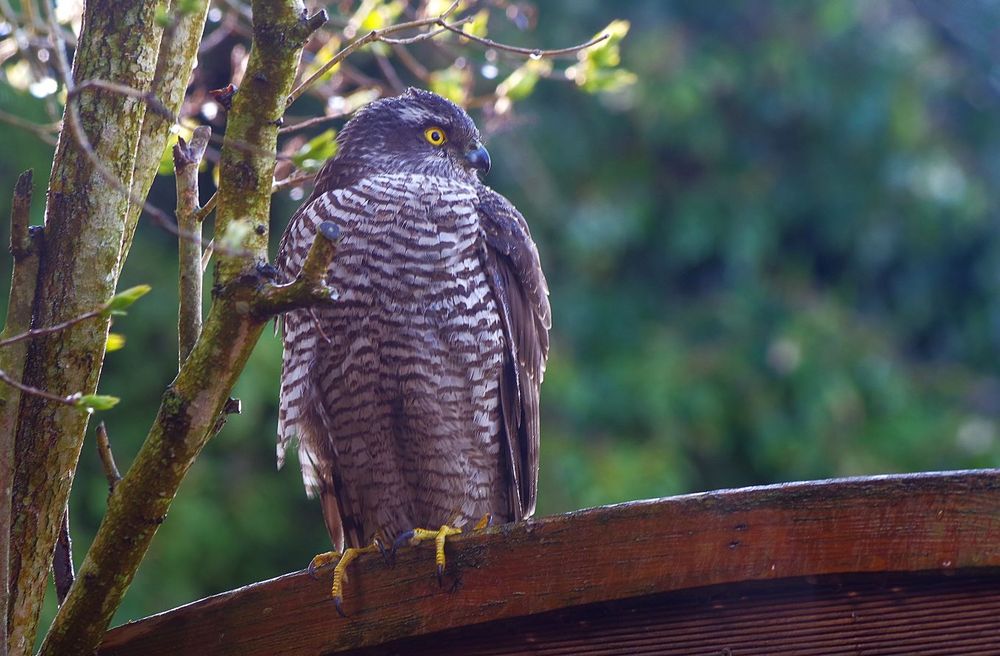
[277,89,551,610]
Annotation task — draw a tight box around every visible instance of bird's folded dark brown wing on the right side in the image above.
[477,187,552,519]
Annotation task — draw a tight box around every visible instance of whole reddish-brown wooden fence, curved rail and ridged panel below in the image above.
[99,470,1000,656]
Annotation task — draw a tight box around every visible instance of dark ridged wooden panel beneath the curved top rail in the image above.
[344,570,1000,656]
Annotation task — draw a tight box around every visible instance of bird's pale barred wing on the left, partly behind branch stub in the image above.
[275,177,364,551]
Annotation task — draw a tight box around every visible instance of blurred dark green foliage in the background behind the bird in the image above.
[0,0,1000,632]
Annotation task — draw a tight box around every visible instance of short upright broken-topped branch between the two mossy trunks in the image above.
[174,126,212,365]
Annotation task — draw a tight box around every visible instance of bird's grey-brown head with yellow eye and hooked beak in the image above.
[337,88,490,180]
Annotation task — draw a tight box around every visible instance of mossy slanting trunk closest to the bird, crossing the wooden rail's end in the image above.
[40,6,333,656]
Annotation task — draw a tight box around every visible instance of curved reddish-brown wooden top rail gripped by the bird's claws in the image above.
[100,470,1000,656]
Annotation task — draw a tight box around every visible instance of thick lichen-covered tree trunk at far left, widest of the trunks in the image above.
[9,0,162,656]
